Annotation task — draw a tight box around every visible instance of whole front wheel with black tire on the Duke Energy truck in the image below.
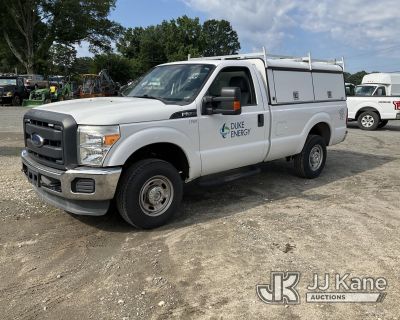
[116,159,183,229]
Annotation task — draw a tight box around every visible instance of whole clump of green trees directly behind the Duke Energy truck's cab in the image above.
[117,16,240,77]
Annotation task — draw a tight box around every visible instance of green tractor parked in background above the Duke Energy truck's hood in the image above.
[22,83,71,107]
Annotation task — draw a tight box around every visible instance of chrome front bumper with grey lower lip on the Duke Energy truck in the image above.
[21,150,122,215]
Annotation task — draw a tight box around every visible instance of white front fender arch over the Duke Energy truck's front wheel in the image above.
[103,126,201,180]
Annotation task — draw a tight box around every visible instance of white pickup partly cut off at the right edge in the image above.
[347,73,400,130]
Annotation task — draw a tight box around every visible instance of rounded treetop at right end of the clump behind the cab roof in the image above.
[202,19,240,56]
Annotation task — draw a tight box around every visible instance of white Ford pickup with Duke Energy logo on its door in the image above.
[22,52,347,228]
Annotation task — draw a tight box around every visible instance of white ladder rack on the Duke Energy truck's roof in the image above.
[188,47,345,71]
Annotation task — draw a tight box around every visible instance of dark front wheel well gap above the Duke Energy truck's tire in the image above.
[124,143,189,180]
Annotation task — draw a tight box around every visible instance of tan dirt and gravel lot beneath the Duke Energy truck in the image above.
[0,108,400,320]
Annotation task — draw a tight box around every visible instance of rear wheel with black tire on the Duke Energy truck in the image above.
[294,135,327,179]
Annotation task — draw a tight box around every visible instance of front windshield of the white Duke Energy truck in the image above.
[127,64,214,104]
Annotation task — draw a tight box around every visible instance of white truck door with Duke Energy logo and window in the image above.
[199,66,269,175]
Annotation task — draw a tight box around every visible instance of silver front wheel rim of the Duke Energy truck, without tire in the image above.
[139,176,174,217]
